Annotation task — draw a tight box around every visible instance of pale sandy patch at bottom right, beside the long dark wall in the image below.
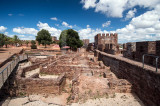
[71,93,144,106]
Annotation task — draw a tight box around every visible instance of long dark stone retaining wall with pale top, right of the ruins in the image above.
[95,50,160,106]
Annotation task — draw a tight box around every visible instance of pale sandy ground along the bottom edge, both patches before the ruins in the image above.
[2,93,144,106]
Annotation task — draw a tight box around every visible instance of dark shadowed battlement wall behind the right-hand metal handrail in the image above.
[123,41,160,66]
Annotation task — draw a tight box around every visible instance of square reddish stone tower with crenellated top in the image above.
[95,33,119,54]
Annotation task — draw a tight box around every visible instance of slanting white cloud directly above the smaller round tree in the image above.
[37,21,61,37]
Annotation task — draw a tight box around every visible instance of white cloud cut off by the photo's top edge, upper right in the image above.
[81,0,160,18]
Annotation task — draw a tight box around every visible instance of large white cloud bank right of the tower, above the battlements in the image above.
[116,5,160,42]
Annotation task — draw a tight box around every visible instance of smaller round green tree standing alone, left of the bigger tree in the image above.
[36,29,52,48]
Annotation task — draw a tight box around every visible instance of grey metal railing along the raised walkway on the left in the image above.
[0,55,28,89]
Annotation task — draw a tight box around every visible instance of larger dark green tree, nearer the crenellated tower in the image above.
[59,29,83,50]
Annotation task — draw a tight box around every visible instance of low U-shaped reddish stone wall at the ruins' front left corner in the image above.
[16,64,66,95]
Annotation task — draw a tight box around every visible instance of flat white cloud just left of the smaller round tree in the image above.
[13,27,38,35]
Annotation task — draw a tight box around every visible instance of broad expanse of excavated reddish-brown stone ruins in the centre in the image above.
[16,53,132,103]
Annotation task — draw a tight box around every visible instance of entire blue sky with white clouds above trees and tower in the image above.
[0,0,160,43]
